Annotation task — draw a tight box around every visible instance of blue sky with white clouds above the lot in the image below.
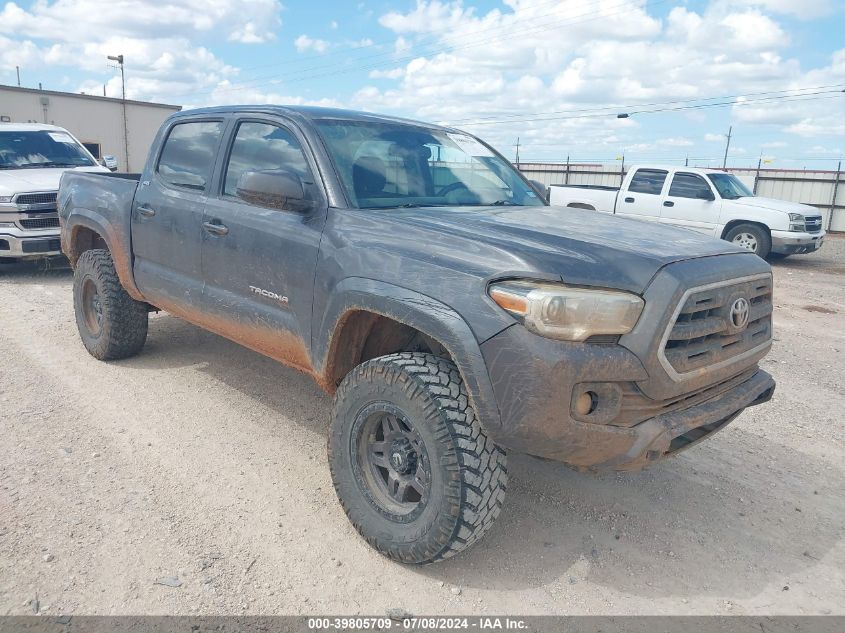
[0,0,845,168]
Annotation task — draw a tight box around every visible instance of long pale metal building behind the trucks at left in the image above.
[0,85,182,172]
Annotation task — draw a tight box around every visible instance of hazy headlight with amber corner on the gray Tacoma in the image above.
[488,281,645,341]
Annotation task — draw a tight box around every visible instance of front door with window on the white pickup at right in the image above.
[660,171,722,235]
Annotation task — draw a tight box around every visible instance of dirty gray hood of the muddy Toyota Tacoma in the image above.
[376,207,753,293]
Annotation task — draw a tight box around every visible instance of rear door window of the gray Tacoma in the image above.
[157,121,223,191]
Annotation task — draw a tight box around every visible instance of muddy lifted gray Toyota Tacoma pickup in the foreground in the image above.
[58,106,775,563]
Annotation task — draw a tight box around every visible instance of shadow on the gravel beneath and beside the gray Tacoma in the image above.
[121,315,845,601]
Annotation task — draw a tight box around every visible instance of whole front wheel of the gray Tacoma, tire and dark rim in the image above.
[328,353,507,564]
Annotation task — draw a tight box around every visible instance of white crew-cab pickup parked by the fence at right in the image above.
[549,165,825,257]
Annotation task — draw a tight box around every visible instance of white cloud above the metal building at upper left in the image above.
[0,0,281,103]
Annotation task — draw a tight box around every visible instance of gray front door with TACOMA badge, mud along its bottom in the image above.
[202,117,327,370]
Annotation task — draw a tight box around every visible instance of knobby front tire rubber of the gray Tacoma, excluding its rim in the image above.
[328,352,507,565]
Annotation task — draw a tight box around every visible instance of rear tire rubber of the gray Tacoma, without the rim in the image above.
[73,249,148,360]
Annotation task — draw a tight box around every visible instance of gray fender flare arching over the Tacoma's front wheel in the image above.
[312,277,501,432]
